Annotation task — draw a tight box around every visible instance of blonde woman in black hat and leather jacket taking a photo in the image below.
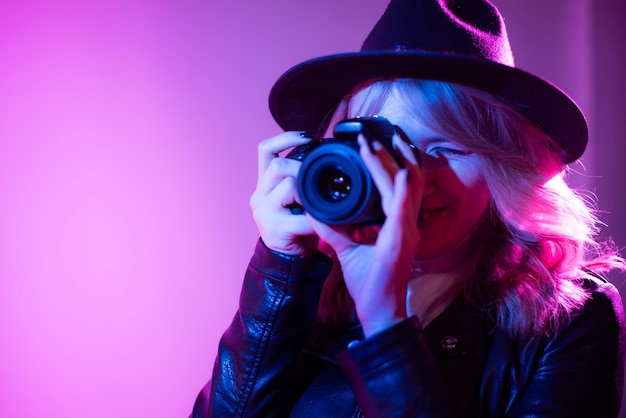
[193,0,624,418]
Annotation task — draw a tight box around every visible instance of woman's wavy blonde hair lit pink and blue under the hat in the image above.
[319,79,625,337]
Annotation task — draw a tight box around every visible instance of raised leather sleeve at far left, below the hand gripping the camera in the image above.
[192,240,332,418]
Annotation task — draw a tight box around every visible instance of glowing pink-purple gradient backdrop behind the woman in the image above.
[0,0,626,418]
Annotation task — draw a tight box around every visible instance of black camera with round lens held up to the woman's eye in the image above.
[287,116,403,225]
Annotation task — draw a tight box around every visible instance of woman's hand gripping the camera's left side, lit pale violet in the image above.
[250,132,318,257]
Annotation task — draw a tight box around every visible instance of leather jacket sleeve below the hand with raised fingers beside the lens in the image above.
[337,317,450,418]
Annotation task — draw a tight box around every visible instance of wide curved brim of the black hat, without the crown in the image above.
[269,51,588,163]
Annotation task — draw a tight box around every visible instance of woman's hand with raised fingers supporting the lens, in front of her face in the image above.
[307,137,424,337]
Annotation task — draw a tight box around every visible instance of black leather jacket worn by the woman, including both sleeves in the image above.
[192,241,624,418]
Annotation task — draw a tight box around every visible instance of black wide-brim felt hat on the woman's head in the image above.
[269,0,588,163]
